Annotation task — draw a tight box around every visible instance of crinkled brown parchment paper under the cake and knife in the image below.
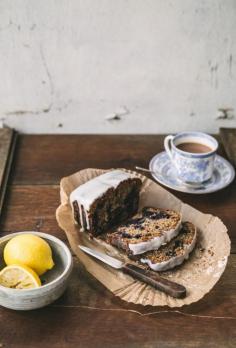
[56,168,230,307]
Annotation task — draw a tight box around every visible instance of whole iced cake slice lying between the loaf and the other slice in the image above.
[106,207,181,256]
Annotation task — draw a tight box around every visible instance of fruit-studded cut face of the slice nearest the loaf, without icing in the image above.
[106,207,181,255]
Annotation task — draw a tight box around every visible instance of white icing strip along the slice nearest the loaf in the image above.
[129,222,181,255]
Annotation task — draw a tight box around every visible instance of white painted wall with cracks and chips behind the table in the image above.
[0,0,236,133]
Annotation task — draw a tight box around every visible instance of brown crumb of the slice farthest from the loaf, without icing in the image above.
[136,222,196,264]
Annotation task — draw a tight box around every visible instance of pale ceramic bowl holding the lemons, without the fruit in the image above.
[0,231,73,310]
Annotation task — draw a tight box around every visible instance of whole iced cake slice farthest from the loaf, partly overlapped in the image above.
[139,222,197,271]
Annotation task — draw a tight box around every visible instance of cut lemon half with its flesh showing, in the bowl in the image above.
[0,265,41,289]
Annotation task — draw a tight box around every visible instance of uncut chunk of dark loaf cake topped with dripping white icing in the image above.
[70,170,142,236]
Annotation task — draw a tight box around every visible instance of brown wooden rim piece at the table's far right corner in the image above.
[220,128,236,167]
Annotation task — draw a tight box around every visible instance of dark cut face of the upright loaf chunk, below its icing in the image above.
[73,178,142,236]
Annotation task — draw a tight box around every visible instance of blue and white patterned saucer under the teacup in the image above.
[149,151,235,194]
